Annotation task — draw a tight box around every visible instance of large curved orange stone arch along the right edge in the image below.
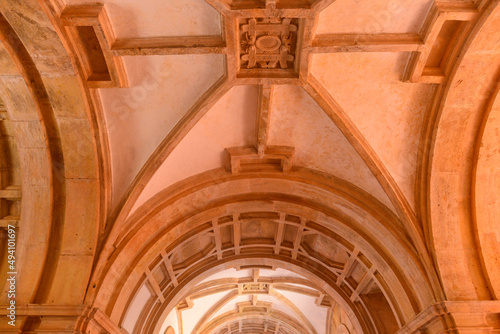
[426,3,500,300]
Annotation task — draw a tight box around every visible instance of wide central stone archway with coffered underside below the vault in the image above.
[90,170,438,333]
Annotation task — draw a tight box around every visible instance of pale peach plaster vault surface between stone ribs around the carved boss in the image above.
[90,1,438,215]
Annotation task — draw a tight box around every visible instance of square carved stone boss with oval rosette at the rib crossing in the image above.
[240,17,297,69]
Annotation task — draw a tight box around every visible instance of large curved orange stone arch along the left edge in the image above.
[0,0,102,318]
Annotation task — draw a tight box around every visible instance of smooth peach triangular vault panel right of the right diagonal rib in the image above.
[312,52,433,209]
